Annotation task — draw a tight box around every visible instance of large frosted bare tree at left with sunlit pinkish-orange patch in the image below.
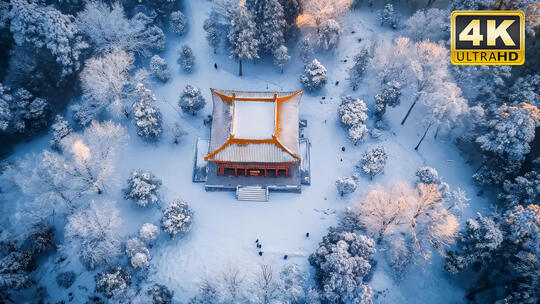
[10,122,127,225]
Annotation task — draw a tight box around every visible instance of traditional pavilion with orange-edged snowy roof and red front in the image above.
[204,89,302,177]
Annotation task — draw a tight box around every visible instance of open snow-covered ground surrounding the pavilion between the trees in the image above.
[5,0,494,303]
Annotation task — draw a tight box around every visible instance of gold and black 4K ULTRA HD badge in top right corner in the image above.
[450,11,525,65]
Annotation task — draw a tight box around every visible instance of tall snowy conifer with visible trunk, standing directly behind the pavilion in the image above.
[227,5,260,76]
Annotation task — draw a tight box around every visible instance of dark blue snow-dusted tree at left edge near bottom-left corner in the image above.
[0,250,36,290]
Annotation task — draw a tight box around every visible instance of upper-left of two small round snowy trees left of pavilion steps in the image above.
[124,170,161,207]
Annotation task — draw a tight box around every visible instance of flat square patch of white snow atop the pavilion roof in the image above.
[232,100,276,139]
